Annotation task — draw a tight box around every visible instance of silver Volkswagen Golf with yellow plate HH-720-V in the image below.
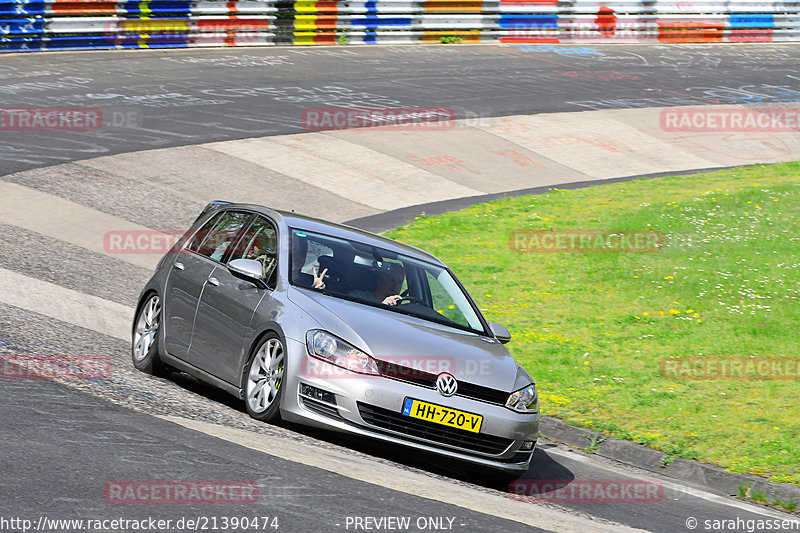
[132,201,539,474]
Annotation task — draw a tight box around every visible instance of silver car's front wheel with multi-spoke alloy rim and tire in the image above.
[244,333,286,422]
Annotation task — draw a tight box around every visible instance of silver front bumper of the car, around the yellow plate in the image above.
[281,339,539,472]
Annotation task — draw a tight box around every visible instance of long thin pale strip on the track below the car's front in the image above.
[158,416,644,533]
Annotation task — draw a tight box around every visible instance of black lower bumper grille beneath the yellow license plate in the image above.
[358,402,514,455]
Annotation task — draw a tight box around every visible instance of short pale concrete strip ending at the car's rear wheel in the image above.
[0,268,134,341]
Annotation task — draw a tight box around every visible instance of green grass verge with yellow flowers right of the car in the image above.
[387,163,800,485]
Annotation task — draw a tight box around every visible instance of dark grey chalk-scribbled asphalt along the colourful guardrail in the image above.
[0,44,800,175]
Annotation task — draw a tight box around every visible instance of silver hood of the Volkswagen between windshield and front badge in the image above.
[289,288,529,392]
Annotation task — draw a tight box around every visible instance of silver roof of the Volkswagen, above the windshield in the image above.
[211,203,445,266]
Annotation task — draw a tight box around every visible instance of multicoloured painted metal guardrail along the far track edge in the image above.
[0,0,800,51]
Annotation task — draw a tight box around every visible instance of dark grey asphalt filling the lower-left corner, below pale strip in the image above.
[0,374,542,532]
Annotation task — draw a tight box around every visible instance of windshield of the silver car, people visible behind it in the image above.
[289,230,485,333]
